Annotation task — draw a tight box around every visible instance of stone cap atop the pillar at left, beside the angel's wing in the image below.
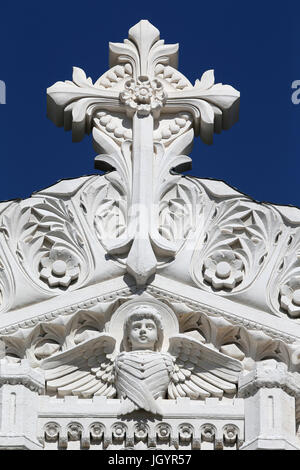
[0,359,45,394]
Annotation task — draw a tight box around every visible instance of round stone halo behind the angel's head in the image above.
[107,298,179,351]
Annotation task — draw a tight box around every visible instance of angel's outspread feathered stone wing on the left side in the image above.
[41,333,116,398]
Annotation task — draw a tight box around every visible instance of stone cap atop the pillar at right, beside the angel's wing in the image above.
[238,359,300,398]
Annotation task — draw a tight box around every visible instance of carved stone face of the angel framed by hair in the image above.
[128,318,158,351]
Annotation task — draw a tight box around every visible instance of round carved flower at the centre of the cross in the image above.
[120,76,167,116]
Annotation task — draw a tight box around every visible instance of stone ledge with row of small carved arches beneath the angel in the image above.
[38,397,244,450]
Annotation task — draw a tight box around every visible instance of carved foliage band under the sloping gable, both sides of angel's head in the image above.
[1,287,300,378]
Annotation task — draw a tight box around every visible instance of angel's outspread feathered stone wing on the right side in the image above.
[168,334,242,400]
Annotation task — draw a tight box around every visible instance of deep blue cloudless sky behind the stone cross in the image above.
[0,0,300,206]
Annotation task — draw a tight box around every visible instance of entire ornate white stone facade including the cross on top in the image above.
[0,20,300,450]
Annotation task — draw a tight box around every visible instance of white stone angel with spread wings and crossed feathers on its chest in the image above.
[42,306,242,415]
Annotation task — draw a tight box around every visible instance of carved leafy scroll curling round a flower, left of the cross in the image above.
[0,198,91,293]
